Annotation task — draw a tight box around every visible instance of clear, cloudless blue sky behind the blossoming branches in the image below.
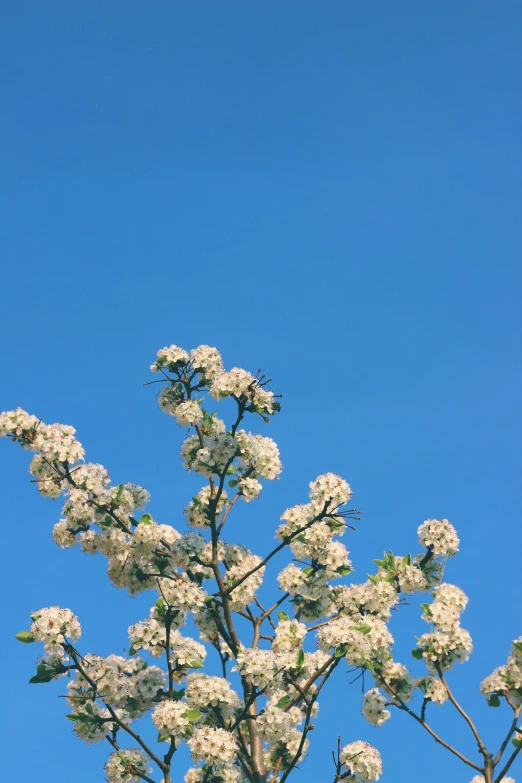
[0,0,522,783]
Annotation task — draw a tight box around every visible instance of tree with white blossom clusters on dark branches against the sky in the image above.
[0,345,522,783]
